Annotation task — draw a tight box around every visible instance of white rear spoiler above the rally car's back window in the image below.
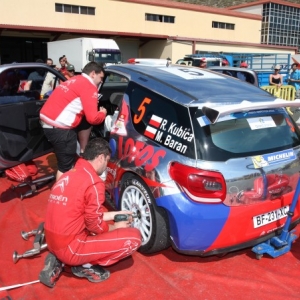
[202,99,300,124]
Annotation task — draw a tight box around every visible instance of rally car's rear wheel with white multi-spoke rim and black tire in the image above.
[120,174,170,254]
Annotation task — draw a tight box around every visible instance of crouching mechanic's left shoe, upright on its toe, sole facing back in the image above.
[39,253,63,288]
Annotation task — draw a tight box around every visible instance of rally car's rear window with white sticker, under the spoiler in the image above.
[194,110,300,161]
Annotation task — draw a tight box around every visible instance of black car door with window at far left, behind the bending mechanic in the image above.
[0,63,65,170]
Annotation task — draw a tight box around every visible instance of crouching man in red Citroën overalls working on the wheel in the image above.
[39,138,141,287]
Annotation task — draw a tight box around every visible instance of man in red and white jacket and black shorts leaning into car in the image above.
[40,62,107,180]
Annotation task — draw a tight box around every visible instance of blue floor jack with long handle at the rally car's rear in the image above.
[252,178,300,259]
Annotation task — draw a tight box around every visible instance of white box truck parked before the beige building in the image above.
[47,38,122,72]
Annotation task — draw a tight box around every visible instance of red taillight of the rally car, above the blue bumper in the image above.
[169,162,226,203]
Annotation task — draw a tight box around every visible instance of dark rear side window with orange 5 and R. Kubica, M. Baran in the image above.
[128,83,195,158]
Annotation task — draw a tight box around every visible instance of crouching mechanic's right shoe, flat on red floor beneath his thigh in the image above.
[71,265,110,282]
